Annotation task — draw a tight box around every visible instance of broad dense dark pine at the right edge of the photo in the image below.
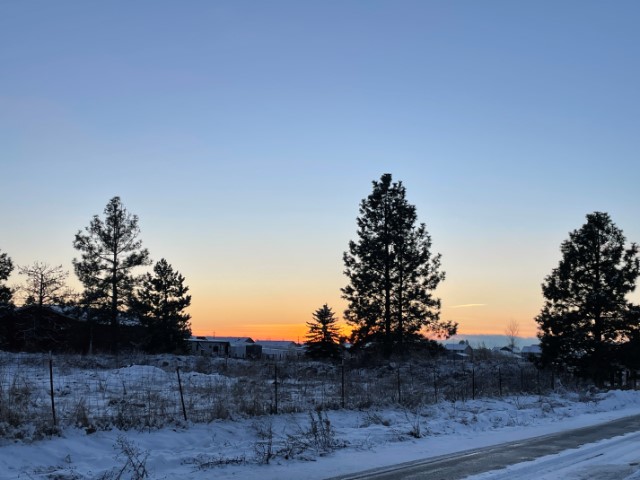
[536,212,640,384]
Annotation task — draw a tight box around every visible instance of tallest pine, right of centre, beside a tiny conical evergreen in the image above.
[342,174,457,356]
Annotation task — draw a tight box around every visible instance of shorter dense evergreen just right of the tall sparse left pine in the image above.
[133,258,191,353]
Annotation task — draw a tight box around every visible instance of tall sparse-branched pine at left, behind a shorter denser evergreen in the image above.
[73,197,150,351]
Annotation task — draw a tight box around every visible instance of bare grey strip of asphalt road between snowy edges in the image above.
[328,415,640,480]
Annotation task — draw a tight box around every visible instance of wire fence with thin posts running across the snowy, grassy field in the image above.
[0,353,600,438]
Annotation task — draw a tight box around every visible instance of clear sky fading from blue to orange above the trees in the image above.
[0,0,640,340]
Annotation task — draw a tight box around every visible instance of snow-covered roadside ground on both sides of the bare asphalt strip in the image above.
[0,382,640,480]
